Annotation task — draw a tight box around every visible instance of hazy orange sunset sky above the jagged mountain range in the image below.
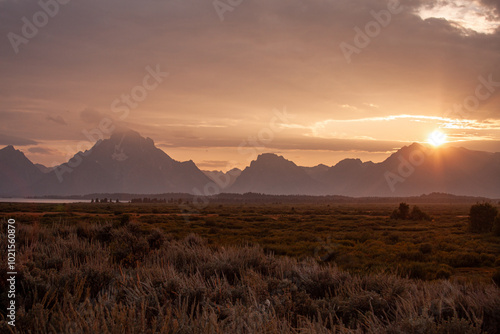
[0,0,500,170]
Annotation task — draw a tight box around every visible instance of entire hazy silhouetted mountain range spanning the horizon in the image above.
[0,130,500,198]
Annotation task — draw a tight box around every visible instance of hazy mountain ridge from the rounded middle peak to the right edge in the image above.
[228,143,500,198]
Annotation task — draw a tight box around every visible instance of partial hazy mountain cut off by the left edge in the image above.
[0,145,43,196]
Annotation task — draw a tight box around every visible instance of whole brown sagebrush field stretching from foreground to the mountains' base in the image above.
[0,203,500,334]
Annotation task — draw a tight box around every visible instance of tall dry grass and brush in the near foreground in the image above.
[0,223,500,334]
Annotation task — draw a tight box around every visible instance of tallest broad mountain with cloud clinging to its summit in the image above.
[35,130,210,195]
